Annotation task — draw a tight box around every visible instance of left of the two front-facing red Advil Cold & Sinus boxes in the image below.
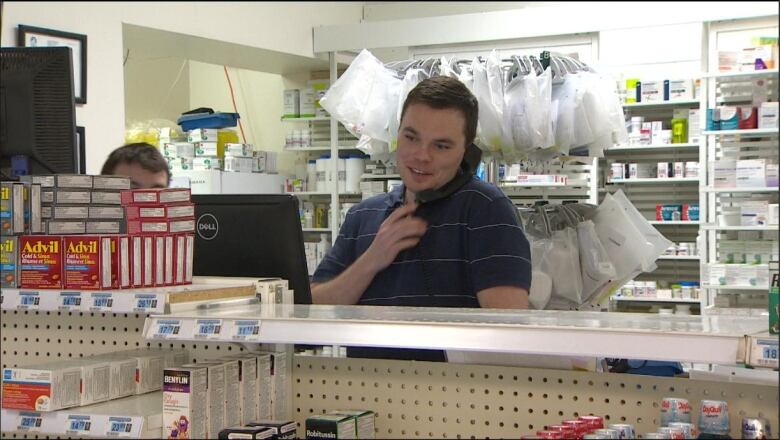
[19,235,64,289]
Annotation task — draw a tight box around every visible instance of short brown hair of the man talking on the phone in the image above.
[401,76,479,147]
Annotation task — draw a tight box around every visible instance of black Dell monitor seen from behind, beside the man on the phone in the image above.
[192,194,311,304]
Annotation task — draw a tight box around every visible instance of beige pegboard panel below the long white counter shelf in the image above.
[293,356,778,439]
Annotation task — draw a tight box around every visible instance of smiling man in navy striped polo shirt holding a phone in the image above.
[312,77,531,360]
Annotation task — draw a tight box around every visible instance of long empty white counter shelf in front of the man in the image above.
[143,304,766,364]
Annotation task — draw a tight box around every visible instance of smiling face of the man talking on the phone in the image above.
[397,104,466,199]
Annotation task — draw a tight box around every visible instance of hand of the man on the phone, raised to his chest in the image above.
[361,202,428,273]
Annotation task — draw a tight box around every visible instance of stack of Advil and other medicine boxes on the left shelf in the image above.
[0,175,195,290]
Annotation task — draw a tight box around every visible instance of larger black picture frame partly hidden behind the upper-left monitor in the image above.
[16,24,87,104]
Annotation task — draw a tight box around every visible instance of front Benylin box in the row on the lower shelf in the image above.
[162,366,209,438]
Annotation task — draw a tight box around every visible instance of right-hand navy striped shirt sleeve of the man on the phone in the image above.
[468,197,531,292]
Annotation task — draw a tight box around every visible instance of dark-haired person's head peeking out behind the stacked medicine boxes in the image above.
[100,142,171,188]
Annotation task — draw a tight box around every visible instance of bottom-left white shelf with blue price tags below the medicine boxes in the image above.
[0,391,162,438]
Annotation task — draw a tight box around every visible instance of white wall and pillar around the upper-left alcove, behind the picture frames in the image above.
[0,1,363,173]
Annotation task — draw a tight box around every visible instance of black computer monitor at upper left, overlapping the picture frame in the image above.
[0,47,79,177]
